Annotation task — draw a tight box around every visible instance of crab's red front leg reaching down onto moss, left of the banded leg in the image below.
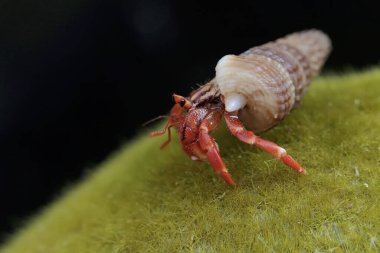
[199,111,235,186]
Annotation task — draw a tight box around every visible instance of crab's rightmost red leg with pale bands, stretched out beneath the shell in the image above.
[224,112,306,175]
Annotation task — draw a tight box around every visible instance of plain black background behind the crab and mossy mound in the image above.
[0,0,380,241]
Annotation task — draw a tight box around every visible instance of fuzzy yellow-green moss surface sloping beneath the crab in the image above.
[0,69,380,253]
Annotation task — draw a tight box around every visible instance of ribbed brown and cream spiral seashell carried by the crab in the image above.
[214,30,331,132]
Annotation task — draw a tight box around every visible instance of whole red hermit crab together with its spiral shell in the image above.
[150,29,331,186]
